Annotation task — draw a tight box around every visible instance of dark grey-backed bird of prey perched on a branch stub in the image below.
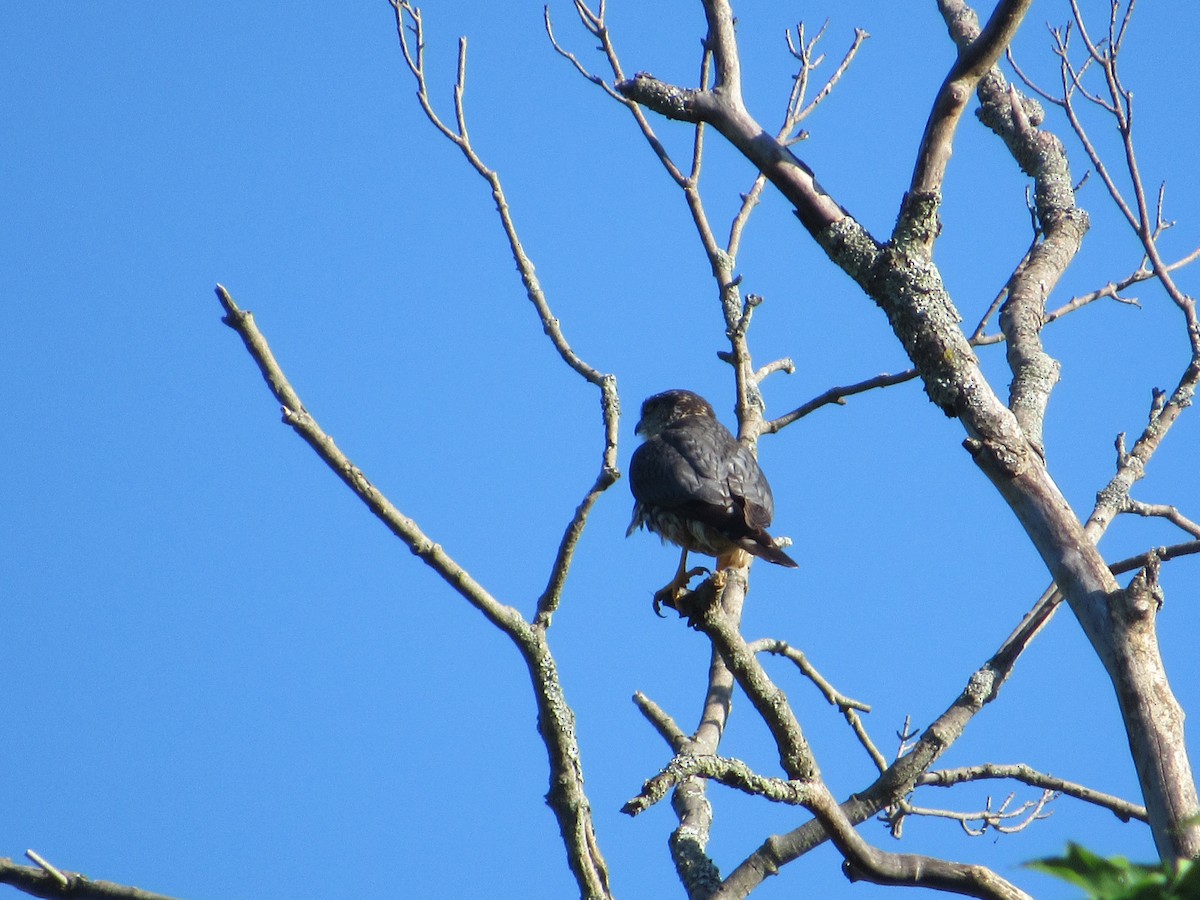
[625,390,797,608]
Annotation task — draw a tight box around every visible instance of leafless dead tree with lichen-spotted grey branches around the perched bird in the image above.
[0,0,1200,900]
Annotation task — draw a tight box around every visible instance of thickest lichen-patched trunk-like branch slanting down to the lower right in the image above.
[617,0,1200,858]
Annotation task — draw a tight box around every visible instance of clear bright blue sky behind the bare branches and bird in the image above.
[0,0,1200,900]
